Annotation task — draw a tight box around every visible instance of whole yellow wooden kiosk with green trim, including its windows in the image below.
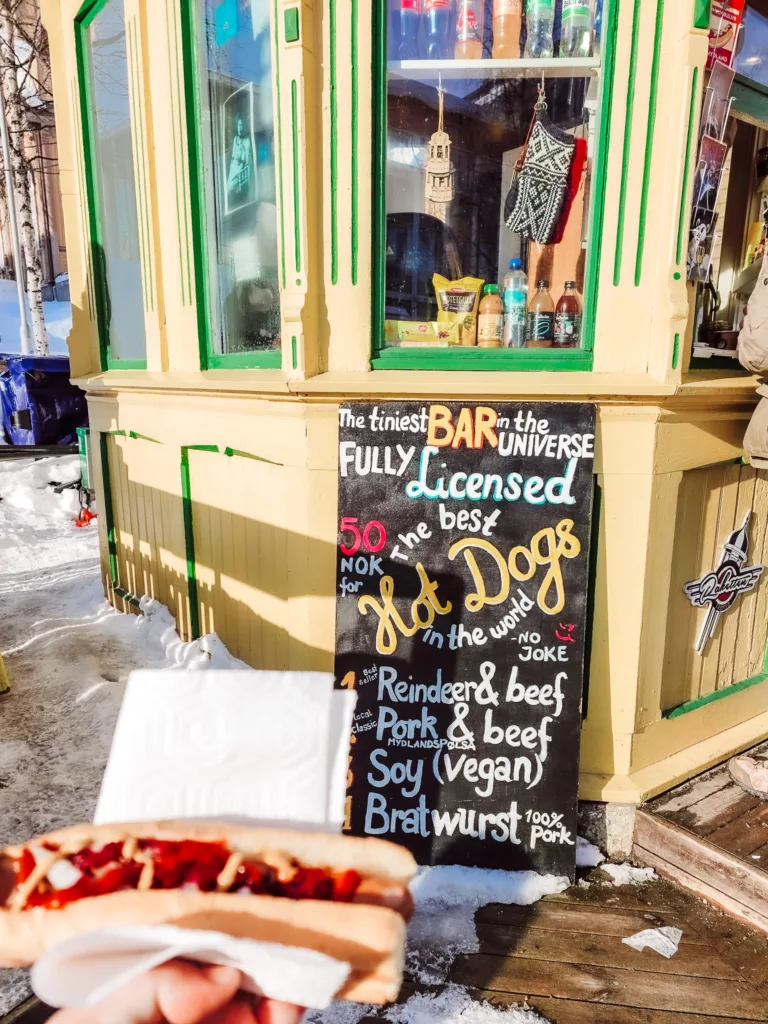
[43,0,768,804]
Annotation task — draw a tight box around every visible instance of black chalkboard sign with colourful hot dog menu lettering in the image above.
[336,402,595,876]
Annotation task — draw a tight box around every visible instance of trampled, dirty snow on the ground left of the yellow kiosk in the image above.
[0,457,245,1017]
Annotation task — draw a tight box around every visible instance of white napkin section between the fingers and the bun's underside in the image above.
[32,925,349,1010]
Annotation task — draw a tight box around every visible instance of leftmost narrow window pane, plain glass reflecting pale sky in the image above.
[87,0,146,360]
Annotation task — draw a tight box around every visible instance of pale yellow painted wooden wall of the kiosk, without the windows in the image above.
[43,0,768,801]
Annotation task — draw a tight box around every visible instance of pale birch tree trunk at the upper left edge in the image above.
[0,0,50,355]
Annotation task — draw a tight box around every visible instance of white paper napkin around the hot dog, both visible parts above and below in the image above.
[32,671,356,1009]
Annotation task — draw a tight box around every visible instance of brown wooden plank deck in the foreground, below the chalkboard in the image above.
[6,870,768,1024]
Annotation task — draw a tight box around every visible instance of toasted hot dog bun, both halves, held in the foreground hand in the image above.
[0,821,416,1004]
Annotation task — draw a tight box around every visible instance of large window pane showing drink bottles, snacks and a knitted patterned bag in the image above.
[384,6,602,352]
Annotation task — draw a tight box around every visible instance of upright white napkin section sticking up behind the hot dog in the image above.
[94,671,356,831]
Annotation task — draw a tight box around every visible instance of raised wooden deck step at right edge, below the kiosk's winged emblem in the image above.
[635,743,768,933]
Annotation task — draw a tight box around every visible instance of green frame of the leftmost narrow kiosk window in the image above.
[75,0,151,372]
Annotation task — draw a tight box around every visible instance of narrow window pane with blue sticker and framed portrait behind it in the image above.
[199,0,281,354]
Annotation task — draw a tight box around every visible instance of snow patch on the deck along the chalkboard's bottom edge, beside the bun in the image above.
[407,866,568,984]
